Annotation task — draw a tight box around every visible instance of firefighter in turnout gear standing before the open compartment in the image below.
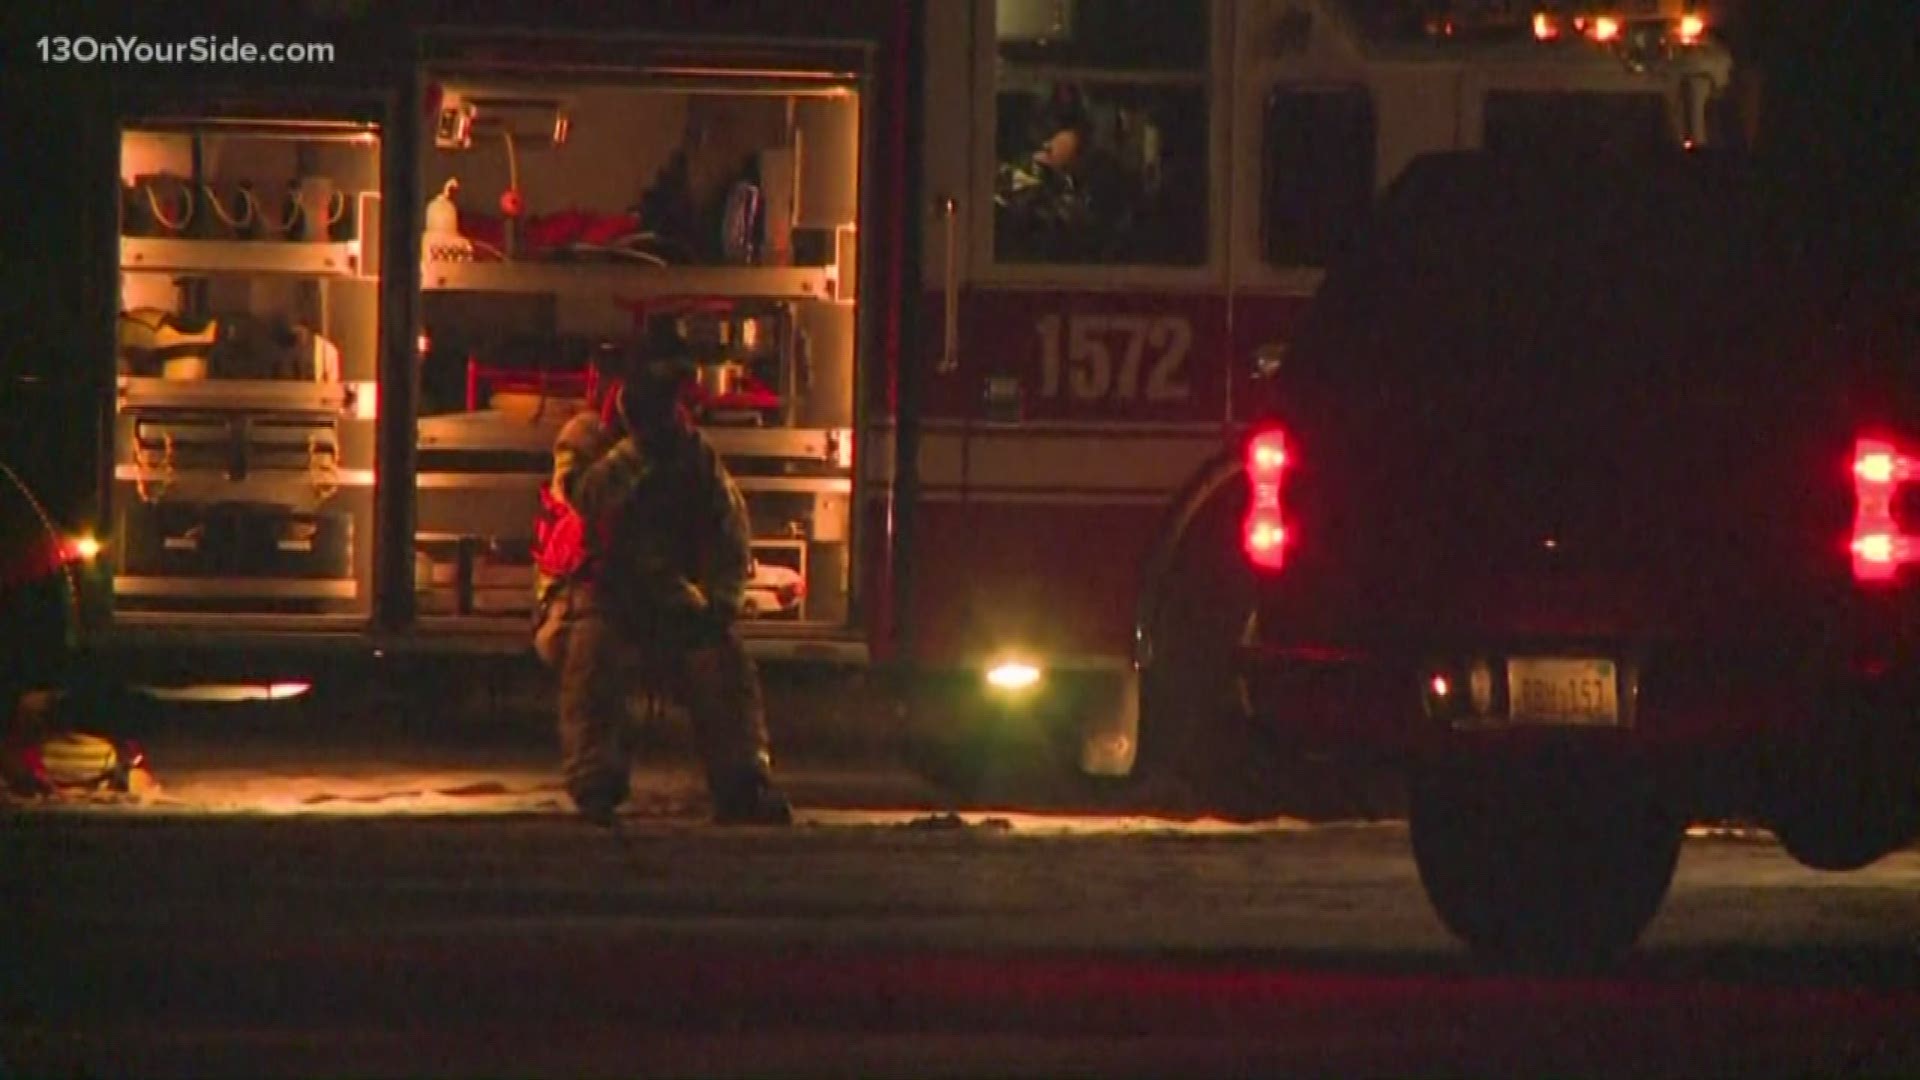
[541,334,793,824]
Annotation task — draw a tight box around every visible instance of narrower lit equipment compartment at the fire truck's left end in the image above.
[109,115,380,626]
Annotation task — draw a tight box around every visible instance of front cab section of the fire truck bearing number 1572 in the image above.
[902,0,1738,799]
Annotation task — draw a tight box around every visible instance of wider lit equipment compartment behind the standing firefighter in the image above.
[415,56,860,640]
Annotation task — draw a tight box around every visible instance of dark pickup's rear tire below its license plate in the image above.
[1409,753,1684,967]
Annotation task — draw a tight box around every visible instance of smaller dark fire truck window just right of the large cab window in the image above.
[1261,86,1375,267]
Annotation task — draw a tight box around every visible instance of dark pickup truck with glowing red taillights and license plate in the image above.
[1240,154,1920,955]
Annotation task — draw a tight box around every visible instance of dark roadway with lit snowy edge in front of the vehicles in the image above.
[0,691,1920,1076]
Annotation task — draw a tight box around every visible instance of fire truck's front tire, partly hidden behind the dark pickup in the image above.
[1135,484,1286,819]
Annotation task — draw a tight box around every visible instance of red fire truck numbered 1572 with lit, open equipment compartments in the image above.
[6,0,1738,796]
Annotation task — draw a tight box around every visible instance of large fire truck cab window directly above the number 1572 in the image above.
[993,0,1208,265]
